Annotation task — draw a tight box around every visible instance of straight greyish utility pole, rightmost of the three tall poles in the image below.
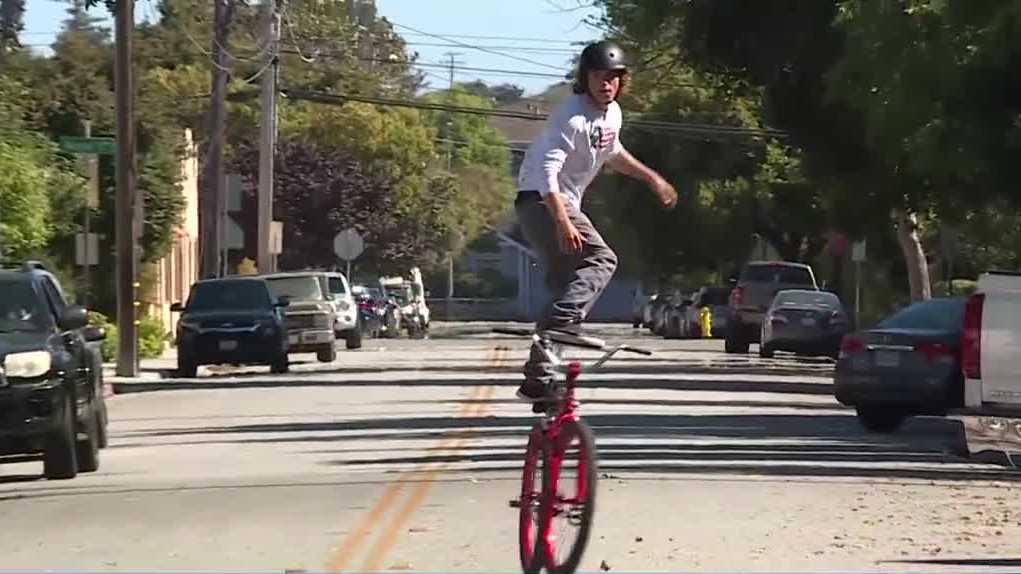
[257,0,280,273]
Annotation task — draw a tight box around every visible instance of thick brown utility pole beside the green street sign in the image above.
[114,0,138,377]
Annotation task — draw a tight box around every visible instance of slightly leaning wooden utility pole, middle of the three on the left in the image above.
[199,0,234,278]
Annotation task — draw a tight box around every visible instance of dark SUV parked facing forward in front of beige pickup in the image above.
[171,277,290,378]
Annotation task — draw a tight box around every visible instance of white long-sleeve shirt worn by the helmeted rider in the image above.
[518,94,624,209]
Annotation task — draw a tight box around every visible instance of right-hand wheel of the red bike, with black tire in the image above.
[540,414,599,574]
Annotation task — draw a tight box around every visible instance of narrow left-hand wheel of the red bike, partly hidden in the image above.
[518,425,546,574]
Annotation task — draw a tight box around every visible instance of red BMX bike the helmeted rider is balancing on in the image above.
[495,329,652,574]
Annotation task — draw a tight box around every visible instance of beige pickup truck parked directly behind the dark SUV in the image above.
[265,272,337,363]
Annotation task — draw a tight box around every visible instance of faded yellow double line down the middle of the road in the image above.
[327,346,508,572]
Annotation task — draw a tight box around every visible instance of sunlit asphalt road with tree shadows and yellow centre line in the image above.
[0,318,1021,572]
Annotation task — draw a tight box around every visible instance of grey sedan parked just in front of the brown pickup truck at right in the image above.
[759,289,850,358]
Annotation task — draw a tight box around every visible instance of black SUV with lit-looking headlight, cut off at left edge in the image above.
[0,264,106,479]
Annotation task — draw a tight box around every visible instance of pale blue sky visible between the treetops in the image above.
[22,0,598,94]
